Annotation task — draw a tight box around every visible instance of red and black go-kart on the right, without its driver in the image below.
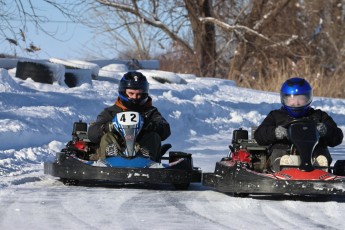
[202,119,345,196]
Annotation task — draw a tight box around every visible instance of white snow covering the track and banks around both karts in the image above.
[0,65,345,229]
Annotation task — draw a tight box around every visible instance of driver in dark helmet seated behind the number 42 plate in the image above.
[88,71,170,162]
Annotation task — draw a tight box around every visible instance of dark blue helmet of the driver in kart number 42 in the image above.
[119,71,149,108]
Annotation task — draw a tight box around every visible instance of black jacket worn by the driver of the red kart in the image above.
[254,108,344,148]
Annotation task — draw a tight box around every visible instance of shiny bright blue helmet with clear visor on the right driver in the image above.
[280,77,313,118]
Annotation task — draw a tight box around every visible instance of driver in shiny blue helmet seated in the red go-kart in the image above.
[254,77,343,171]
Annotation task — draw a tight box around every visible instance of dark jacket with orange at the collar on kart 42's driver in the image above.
[88,97,171,143]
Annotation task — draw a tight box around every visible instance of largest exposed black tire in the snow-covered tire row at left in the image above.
[16,61,54,84]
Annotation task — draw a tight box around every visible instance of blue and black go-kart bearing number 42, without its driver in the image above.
[44,111,201,189]
